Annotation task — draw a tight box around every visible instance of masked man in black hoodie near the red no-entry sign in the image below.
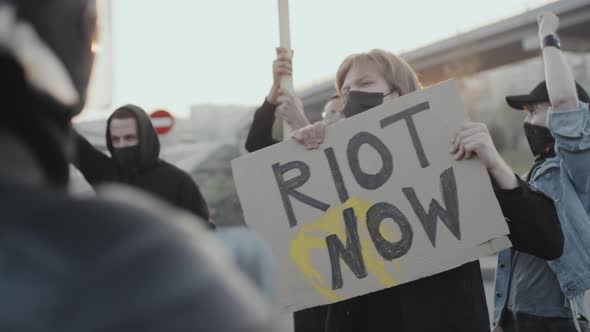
[74,105,213,227]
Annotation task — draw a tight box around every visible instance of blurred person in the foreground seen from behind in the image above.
[0,0,274,332]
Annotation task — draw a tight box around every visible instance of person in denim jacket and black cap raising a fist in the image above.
[493,14,590,332]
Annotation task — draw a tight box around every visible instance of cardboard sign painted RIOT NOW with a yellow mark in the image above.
[233,81,510,311]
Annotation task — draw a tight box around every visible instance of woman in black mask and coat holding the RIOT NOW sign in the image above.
[292,50,563,332]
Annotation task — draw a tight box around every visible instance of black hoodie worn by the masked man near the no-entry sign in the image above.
[74,105,209,224]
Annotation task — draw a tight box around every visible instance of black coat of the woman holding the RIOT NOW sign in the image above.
[326,180,563,332]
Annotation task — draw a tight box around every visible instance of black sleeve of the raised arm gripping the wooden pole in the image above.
[246,99,279,152]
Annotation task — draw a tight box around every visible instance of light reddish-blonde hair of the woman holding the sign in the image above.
[336,49,422,96]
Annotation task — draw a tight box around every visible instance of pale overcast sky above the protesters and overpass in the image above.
[100,0,551,115]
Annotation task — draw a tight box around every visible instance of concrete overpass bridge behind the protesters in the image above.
[300,0,590,121]
